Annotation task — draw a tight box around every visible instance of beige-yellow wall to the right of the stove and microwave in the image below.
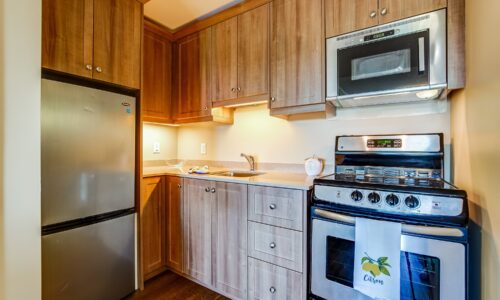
[452,0,500,299]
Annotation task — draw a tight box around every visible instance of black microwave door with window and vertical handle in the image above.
[337,30,429,97]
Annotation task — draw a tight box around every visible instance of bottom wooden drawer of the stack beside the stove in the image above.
[248,258,303,300]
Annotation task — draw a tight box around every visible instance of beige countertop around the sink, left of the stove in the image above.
[143,166,314,190]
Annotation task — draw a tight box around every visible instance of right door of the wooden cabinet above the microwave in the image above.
[379,0,446,24]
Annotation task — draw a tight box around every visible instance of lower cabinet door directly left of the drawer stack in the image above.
[213,182,247,299]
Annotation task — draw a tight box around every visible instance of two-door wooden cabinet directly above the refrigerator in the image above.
[42,0,142,89]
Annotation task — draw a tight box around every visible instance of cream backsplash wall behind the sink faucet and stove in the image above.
[178,102,450,164]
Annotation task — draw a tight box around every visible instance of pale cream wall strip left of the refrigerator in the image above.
[0,0,41,299]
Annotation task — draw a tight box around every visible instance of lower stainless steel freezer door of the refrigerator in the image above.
[42,214,135,300]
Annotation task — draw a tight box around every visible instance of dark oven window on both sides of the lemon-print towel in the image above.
[326,236,440,300]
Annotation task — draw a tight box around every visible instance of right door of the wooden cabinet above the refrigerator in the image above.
[93,0,142,89]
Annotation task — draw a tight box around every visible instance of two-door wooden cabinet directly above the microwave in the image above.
[325,0,446,37]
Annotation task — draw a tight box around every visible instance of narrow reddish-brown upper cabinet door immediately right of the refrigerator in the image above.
[142,27,172,122]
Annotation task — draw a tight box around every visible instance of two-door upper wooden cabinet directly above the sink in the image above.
[211,4,270,106]
